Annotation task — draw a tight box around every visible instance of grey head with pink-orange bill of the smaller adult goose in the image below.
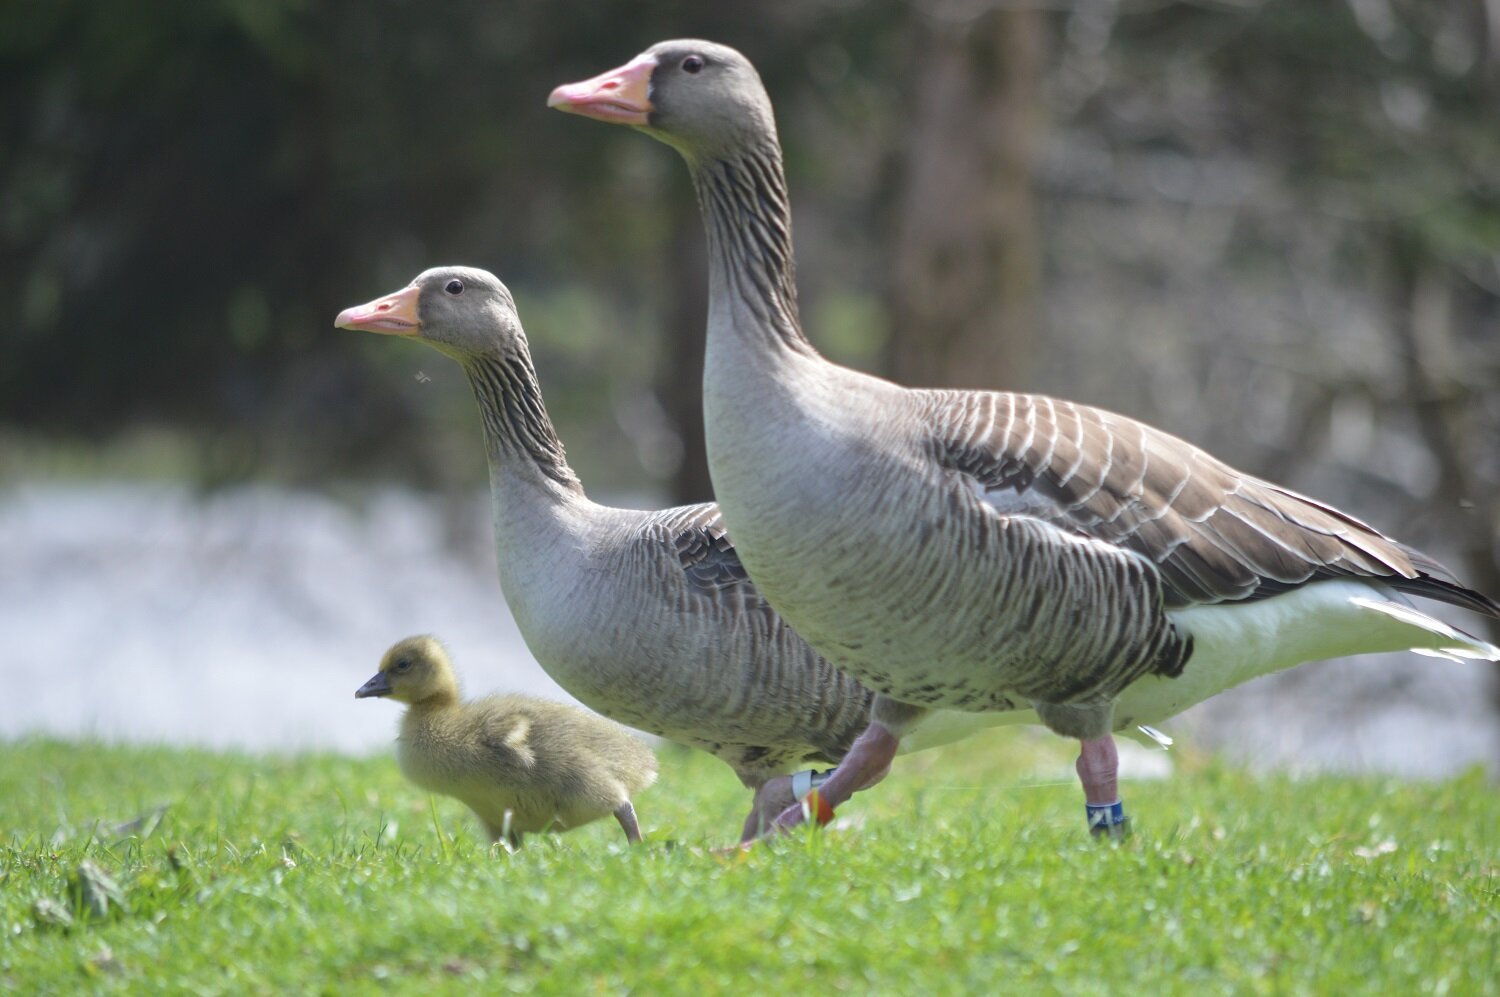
[333,267,524,360]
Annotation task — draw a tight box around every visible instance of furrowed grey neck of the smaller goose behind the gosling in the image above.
[462,346,584,501]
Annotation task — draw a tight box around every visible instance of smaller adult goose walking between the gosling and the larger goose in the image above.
[335,267,993,838]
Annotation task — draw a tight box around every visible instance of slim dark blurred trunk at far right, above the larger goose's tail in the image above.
[1391,234,1500,743]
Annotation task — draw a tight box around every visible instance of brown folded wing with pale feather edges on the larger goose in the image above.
[929,391,1500,616]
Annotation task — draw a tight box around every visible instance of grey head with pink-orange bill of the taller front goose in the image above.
[548,39,776,160]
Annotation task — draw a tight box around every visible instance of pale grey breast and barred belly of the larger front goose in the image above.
[705,365,1170,712]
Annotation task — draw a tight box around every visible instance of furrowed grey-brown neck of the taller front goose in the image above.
[690,135,818,357]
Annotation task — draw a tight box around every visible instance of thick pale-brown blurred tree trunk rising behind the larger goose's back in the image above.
[887,3,1046,388]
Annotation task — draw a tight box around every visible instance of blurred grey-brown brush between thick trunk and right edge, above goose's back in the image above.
[1044,0,1500,602]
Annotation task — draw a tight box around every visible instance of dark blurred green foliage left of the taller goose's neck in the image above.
[0,0,900,483]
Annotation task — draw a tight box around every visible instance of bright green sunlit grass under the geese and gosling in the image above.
[0,733,1500,994]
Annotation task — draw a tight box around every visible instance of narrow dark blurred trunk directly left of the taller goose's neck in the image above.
[657,184,714,504]
